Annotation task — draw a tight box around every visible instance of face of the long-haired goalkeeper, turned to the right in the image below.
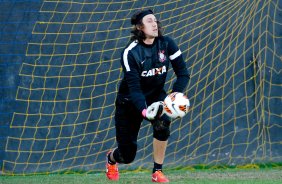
[142,14,158,39]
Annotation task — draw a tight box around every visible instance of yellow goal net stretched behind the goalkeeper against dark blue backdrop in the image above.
[2,0,282,175]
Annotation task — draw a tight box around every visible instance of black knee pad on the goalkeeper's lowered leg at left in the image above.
[113,143,137,164]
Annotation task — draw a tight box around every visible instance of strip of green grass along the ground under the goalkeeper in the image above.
[0,169,282,184]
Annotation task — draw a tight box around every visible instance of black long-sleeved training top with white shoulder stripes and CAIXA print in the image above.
[118,36,190,113]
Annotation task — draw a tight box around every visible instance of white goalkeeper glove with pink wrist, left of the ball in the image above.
[142,101,163,120]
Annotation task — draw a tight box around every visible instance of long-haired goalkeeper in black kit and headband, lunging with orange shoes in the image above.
[106,10,189,182]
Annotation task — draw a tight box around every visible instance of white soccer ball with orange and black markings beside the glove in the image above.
[163,92,190,119]
